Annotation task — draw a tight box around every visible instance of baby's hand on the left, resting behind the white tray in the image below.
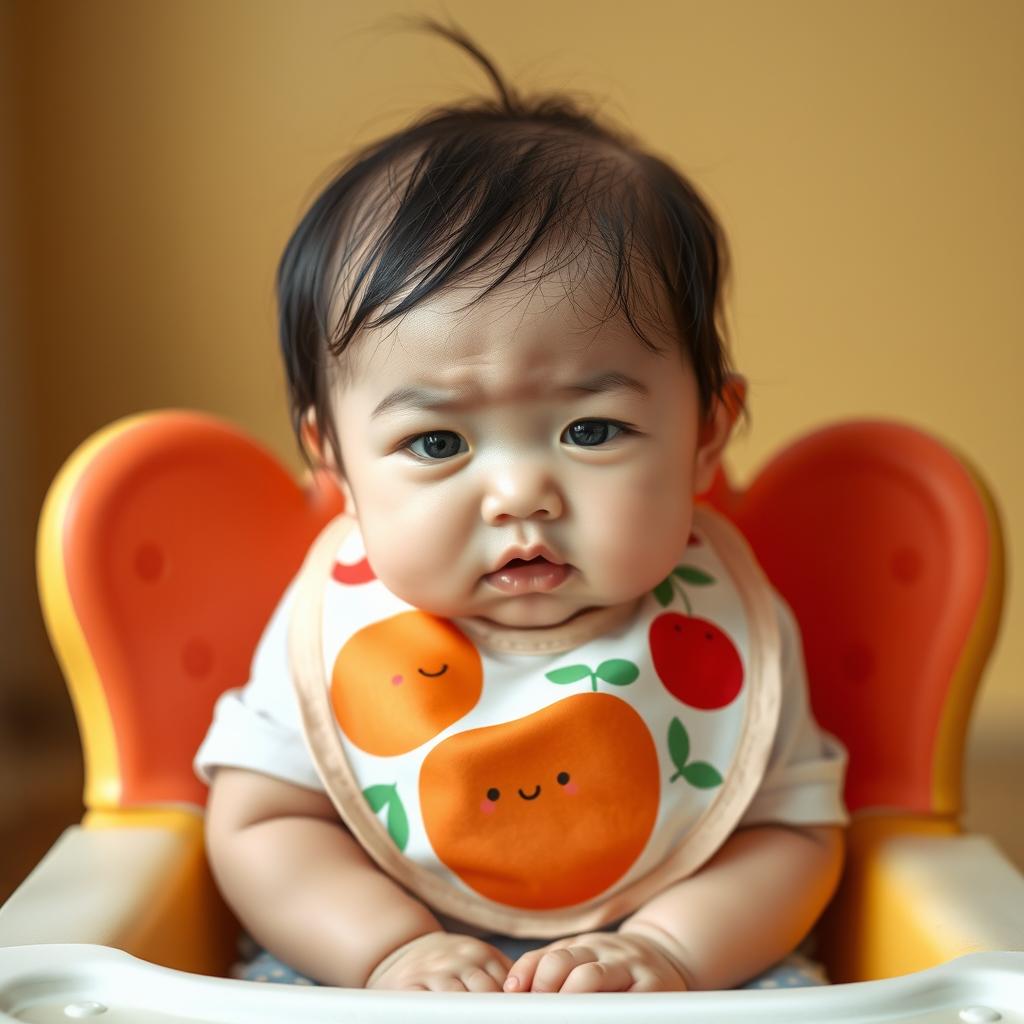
[367,932,512,992]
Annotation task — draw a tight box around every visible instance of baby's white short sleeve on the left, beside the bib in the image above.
[193,581,324,792]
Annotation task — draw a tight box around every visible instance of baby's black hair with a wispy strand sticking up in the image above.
[276,17,730,463]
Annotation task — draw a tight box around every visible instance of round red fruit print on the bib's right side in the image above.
[648,611,743,711]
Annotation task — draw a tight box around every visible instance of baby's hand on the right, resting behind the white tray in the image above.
[505,932,687,992]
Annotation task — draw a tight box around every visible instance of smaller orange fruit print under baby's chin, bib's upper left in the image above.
[331,611,483,757]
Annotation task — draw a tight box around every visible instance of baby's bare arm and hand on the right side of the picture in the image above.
[505,825,843,992]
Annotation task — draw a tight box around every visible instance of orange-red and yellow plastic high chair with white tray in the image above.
[0,412,1024,1024]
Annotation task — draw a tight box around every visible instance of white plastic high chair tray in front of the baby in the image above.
[0,946,1024,1024]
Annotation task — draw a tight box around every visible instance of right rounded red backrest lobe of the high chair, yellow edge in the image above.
[727,421,1004,815]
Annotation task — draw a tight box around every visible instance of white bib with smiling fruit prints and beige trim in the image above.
[289,507,781,937]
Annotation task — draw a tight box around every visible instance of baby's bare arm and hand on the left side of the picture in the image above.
[206,768,509,991]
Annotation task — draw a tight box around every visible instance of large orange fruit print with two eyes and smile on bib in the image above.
[420,693,659,909]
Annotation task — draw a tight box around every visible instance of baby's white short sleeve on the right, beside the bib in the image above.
[739,594,849,827]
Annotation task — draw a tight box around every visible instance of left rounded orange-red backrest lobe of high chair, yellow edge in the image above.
[38,413,341,810]
